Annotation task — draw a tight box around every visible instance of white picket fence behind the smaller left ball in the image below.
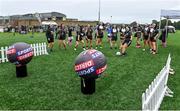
[0,43,48,63]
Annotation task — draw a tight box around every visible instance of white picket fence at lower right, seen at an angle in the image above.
[142,54,174,111]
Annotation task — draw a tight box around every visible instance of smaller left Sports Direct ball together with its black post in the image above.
[7,42,34,77]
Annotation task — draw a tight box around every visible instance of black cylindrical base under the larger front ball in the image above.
[81,78,96,94]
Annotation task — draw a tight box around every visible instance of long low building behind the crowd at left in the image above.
[0,12,97,27]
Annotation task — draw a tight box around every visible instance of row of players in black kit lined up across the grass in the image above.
[46,24,159,56]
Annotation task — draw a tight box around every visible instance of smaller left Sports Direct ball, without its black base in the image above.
[7,42,34,65]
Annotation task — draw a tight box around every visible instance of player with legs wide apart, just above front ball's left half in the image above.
[74,26,86,51]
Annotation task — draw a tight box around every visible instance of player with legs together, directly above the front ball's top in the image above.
[86,24,93,49]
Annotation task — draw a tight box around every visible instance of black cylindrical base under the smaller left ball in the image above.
[16,65,27,78]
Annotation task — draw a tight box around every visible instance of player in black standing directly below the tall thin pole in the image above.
[96,25,104,49]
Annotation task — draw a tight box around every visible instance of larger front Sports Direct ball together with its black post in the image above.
[74,49,107,94]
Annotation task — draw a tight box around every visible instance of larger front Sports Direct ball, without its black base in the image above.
[74,49,107,79]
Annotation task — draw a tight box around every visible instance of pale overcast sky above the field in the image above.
[0,0,180,23]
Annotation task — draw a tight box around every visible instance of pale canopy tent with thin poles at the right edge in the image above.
[156,10,180,51]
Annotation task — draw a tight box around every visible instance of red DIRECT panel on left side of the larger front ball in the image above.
[75,60,94,71]
